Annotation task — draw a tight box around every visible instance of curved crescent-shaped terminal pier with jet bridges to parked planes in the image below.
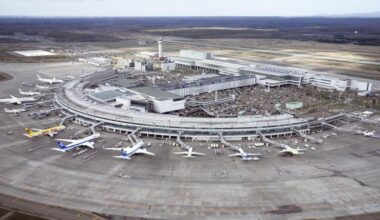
[56,72,342,140]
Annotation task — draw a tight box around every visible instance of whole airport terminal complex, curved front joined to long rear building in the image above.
[56,47,371,140]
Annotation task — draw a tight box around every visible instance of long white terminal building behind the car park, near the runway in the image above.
[170,50,372,92]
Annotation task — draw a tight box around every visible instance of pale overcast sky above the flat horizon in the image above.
[0,0,380,16]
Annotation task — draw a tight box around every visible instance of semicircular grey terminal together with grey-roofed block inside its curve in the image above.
[55,72,348,140]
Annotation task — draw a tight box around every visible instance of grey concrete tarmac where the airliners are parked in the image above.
[0,61,380,219]
